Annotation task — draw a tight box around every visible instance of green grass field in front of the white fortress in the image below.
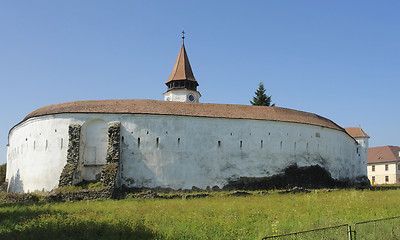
[0,190,400,239]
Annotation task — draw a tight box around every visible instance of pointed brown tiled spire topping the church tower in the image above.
[165,35,198,85]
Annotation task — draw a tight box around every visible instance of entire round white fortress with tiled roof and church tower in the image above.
[6,37,369,192]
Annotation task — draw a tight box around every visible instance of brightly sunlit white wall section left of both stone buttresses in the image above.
[6,115,70,192]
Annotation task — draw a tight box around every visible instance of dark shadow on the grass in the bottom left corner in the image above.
[0,206,161,240]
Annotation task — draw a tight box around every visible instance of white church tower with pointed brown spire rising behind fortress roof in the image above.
[163,31,201,103]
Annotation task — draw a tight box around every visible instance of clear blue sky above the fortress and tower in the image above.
[0,0,400,163]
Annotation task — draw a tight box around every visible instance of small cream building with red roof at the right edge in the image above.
[367,146,400,184]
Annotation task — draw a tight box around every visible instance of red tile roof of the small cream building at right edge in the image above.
[368,146,400,163]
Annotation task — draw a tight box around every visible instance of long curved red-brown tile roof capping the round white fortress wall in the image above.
[23,99,345,132]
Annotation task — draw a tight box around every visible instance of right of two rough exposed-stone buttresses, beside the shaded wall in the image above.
[100,122,121,194]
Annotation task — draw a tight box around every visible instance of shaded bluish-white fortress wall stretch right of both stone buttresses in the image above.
[121,115,362,189]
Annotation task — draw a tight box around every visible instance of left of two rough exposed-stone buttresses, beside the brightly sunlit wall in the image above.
[58,125,81,187]
